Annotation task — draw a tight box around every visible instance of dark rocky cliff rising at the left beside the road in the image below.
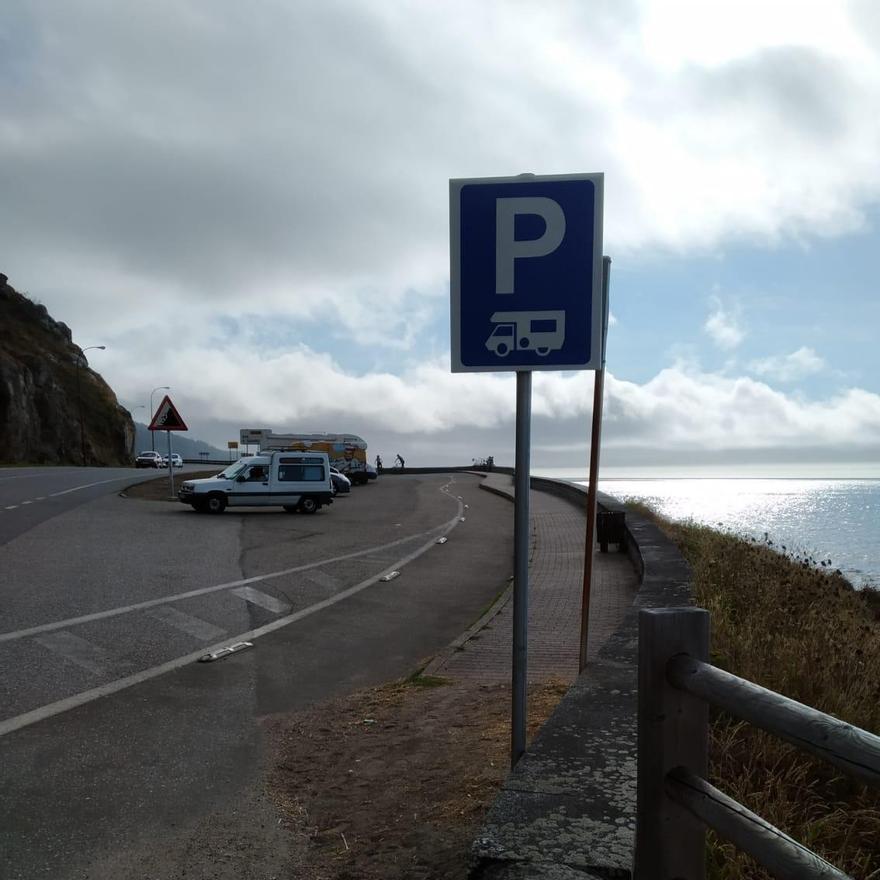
[0,273,134,465]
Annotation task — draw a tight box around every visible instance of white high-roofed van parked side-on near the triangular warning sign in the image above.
[177,452,333,513]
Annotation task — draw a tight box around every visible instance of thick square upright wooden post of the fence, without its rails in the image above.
[633,608,709,880]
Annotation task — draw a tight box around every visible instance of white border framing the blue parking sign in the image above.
[449,172,605,373]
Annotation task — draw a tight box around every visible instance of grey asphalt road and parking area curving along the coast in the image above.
[0,469,512,880]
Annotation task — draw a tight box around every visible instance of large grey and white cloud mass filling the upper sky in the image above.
[0,0,880,344]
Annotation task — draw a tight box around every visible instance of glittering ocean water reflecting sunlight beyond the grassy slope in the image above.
[532,474,880,588]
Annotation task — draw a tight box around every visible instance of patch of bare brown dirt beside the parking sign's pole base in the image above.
[264,677,567,880]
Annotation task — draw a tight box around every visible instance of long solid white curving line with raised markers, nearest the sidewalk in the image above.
[0,502,461,736]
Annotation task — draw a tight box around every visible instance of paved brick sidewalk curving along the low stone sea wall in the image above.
[429,474,638,682]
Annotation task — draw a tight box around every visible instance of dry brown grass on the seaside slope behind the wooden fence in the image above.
[628,513,880,880]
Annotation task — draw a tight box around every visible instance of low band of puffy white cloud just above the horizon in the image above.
[105,334,880,459]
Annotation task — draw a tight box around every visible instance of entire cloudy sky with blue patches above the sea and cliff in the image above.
[0,0,880,475]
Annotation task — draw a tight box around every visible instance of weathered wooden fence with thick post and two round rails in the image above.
[633,608,880,880]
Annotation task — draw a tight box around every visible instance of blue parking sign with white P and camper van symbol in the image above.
[449,174,603,372]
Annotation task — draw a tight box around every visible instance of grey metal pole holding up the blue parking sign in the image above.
[510,370,532,767]
